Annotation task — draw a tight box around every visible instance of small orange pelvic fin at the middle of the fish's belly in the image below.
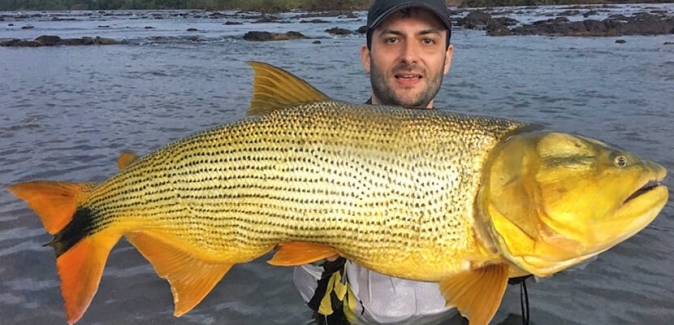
[267,242,337,266]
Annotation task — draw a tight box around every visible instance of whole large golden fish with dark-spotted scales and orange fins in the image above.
[9,63,668,325]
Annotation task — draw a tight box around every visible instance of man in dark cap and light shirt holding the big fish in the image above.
[294,0,465,325]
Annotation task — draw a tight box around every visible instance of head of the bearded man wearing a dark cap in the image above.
[361,8,454,108]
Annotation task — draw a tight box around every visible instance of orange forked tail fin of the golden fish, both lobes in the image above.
[8,181,121,324]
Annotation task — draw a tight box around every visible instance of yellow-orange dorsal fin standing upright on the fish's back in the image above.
[246,61,329,115]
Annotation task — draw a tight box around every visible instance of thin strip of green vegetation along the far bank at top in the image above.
[0,0,672,12]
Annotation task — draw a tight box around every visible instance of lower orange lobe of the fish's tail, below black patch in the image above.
[56,232,121,325]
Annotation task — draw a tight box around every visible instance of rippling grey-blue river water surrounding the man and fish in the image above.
[0,5,674,325]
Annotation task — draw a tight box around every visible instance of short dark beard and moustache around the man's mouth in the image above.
[370,60,445,108]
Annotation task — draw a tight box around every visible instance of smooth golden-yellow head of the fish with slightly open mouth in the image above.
[476,131,668,277]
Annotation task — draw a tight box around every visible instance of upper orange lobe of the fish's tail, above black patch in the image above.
[7,181,94,235]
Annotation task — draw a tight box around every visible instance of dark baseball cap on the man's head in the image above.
[367,0,452,47]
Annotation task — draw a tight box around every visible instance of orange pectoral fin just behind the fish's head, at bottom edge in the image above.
[440,264,508,325]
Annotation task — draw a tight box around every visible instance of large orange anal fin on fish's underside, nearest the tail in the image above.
[126,232,232,317]
